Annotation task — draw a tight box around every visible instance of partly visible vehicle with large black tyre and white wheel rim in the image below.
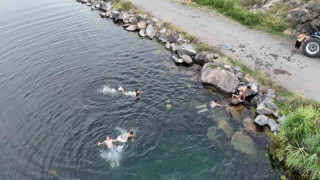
[302,32,320,57]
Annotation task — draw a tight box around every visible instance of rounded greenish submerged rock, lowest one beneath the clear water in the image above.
[231,131,256,155]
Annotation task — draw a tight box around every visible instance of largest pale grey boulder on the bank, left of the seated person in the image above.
[200,63,240,93]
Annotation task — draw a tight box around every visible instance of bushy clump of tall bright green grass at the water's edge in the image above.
[273,105,320,179]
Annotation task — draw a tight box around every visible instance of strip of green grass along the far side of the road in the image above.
[189,0,288,34]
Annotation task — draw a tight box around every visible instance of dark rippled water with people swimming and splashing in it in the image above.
[0,0,281,180]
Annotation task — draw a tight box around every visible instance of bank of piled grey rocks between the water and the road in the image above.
[77,0,286,149]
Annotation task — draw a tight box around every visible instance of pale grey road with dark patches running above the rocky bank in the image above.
[132,0,320,101]
